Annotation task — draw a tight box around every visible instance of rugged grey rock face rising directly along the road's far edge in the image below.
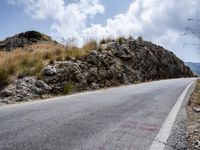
[0,35,193,103]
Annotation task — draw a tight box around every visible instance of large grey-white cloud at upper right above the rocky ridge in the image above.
[84,0,200,47]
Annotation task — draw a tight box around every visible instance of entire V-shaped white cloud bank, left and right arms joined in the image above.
[8,0,200,47]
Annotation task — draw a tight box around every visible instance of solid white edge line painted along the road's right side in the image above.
[149,82,195,150]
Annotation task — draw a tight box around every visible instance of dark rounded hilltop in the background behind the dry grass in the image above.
[0,31,56,51]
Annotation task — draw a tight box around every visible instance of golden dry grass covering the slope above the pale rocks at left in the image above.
[0,41,97,87]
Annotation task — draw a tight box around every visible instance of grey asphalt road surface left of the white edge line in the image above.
[0,79,195,150]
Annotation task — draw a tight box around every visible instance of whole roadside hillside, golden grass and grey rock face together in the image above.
[0,31,193,103]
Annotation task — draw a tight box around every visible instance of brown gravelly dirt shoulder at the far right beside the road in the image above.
[187,80,200,150]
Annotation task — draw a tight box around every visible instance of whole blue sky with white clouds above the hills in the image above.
[0,0,200,62]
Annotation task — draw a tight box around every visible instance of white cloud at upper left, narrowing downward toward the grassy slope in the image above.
[8,0,104,43]
